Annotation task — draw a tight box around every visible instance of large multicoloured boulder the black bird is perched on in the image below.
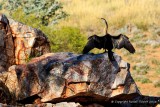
[0,53,140,103]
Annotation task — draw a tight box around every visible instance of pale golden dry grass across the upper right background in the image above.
[59,0,160,33]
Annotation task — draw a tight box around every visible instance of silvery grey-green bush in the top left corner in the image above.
[0,0,67,26]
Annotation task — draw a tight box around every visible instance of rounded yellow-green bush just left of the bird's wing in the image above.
[49,27,87,53]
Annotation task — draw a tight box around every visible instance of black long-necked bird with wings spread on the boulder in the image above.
[83,19,135,60]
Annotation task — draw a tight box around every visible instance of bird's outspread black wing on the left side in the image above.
[83,35,100,54]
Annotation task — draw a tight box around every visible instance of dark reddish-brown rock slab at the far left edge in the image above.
[0,14,15,73]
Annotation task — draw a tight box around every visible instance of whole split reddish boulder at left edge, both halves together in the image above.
[0,14,50,72]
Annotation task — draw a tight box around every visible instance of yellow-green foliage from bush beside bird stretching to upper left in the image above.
[9,9,87,53]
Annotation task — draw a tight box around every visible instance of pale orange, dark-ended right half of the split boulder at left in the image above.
[9,19,50,64]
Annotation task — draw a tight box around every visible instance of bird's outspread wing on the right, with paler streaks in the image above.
[112,34,135,53]
